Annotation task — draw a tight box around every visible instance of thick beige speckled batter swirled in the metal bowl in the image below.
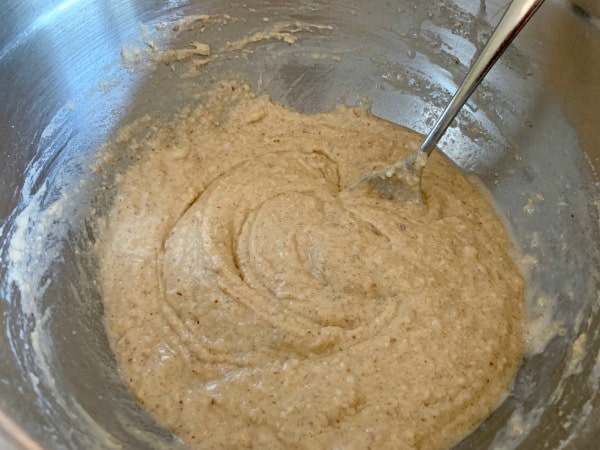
[98,83,523,449]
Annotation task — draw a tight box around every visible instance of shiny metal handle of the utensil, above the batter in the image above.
[419,0,544,156]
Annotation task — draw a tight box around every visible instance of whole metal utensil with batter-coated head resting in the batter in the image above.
[350,0,544,203]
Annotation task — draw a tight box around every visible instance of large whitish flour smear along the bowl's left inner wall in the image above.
[0,148,96,440]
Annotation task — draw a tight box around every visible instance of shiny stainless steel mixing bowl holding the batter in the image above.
[0,0,600,449]
